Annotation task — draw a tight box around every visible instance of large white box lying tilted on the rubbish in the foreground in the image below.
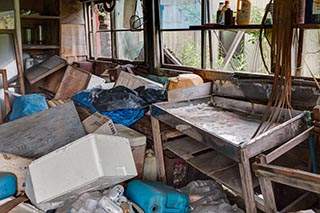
[26,134,137,206]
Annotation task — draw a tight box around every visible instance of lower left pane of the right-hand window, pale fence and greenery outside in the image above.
[162,31,201,68]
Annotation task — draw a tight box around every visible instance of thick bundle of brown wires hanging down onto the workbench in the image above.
[253,1,297,137]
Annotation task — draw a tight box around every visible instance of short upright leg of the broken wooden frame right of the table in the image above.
[258,155,277,213]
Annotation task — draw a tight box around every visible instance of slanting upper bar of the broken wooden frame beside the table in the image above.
[265,127,314,164]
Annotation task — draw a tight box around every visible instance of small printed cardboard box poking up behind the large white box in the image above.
[82,112,117,135]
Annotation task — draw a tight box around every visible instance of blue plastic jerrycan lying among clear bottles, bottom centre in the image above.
[126,180,190,213]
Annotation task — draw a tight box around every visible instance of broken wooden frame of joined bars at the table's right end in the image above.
[253,127,320,212]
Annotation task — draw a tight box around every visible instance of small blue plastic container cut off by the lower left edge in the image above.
[0,172,17,200]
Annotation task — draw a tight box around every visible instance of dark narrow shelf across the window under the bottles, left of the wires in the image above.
[189,24,272,30]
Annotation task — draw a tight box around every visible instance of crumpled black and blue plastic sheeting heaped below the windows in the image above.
[71,85,167,126]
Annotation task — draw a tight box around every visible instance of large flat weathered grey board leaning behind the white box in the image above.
[0,102,85,158]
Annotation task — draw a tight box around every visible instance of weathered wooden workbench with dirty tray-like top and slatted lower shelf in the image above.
[151,97,307,212]
